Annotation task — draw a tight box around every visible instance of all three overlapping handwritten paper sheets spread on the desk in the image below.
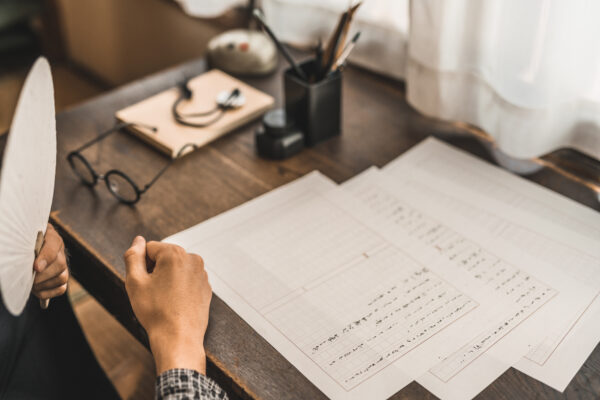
[165,139,600,399]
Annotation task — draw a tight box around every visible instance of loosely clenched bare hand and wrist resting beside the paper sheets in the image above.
[124,236,212,375]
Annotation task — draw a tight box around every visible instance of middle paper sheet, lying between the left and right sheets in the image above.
[343,169,595,398]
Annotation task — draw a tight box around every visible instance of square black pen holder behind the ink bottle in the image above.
[284,60,342,146]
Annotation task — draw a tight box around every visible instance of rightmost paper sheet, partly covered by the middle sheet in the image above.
[384,139,600,391]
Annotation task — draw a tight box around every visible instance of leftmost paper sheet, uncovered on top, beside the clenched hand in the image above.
[166,173,506,399]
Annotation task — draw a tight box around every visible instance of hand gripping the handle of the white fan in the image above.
[31,224,69,300]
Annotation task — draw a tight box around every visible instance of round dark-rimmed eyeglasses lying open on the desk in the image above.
[67,123,197,204]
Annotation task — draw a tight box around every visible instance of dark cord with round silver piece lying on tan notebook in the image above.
[171,81,246,128]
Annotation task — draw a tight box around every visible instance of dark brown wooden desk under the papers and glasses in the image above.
[0,60,600,399]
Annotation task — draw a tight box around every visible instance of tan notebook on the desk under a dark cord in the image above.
[116,69,274,158]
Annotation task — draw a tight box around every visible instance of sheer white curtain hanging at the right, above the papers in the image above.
[406,0,600,158]
